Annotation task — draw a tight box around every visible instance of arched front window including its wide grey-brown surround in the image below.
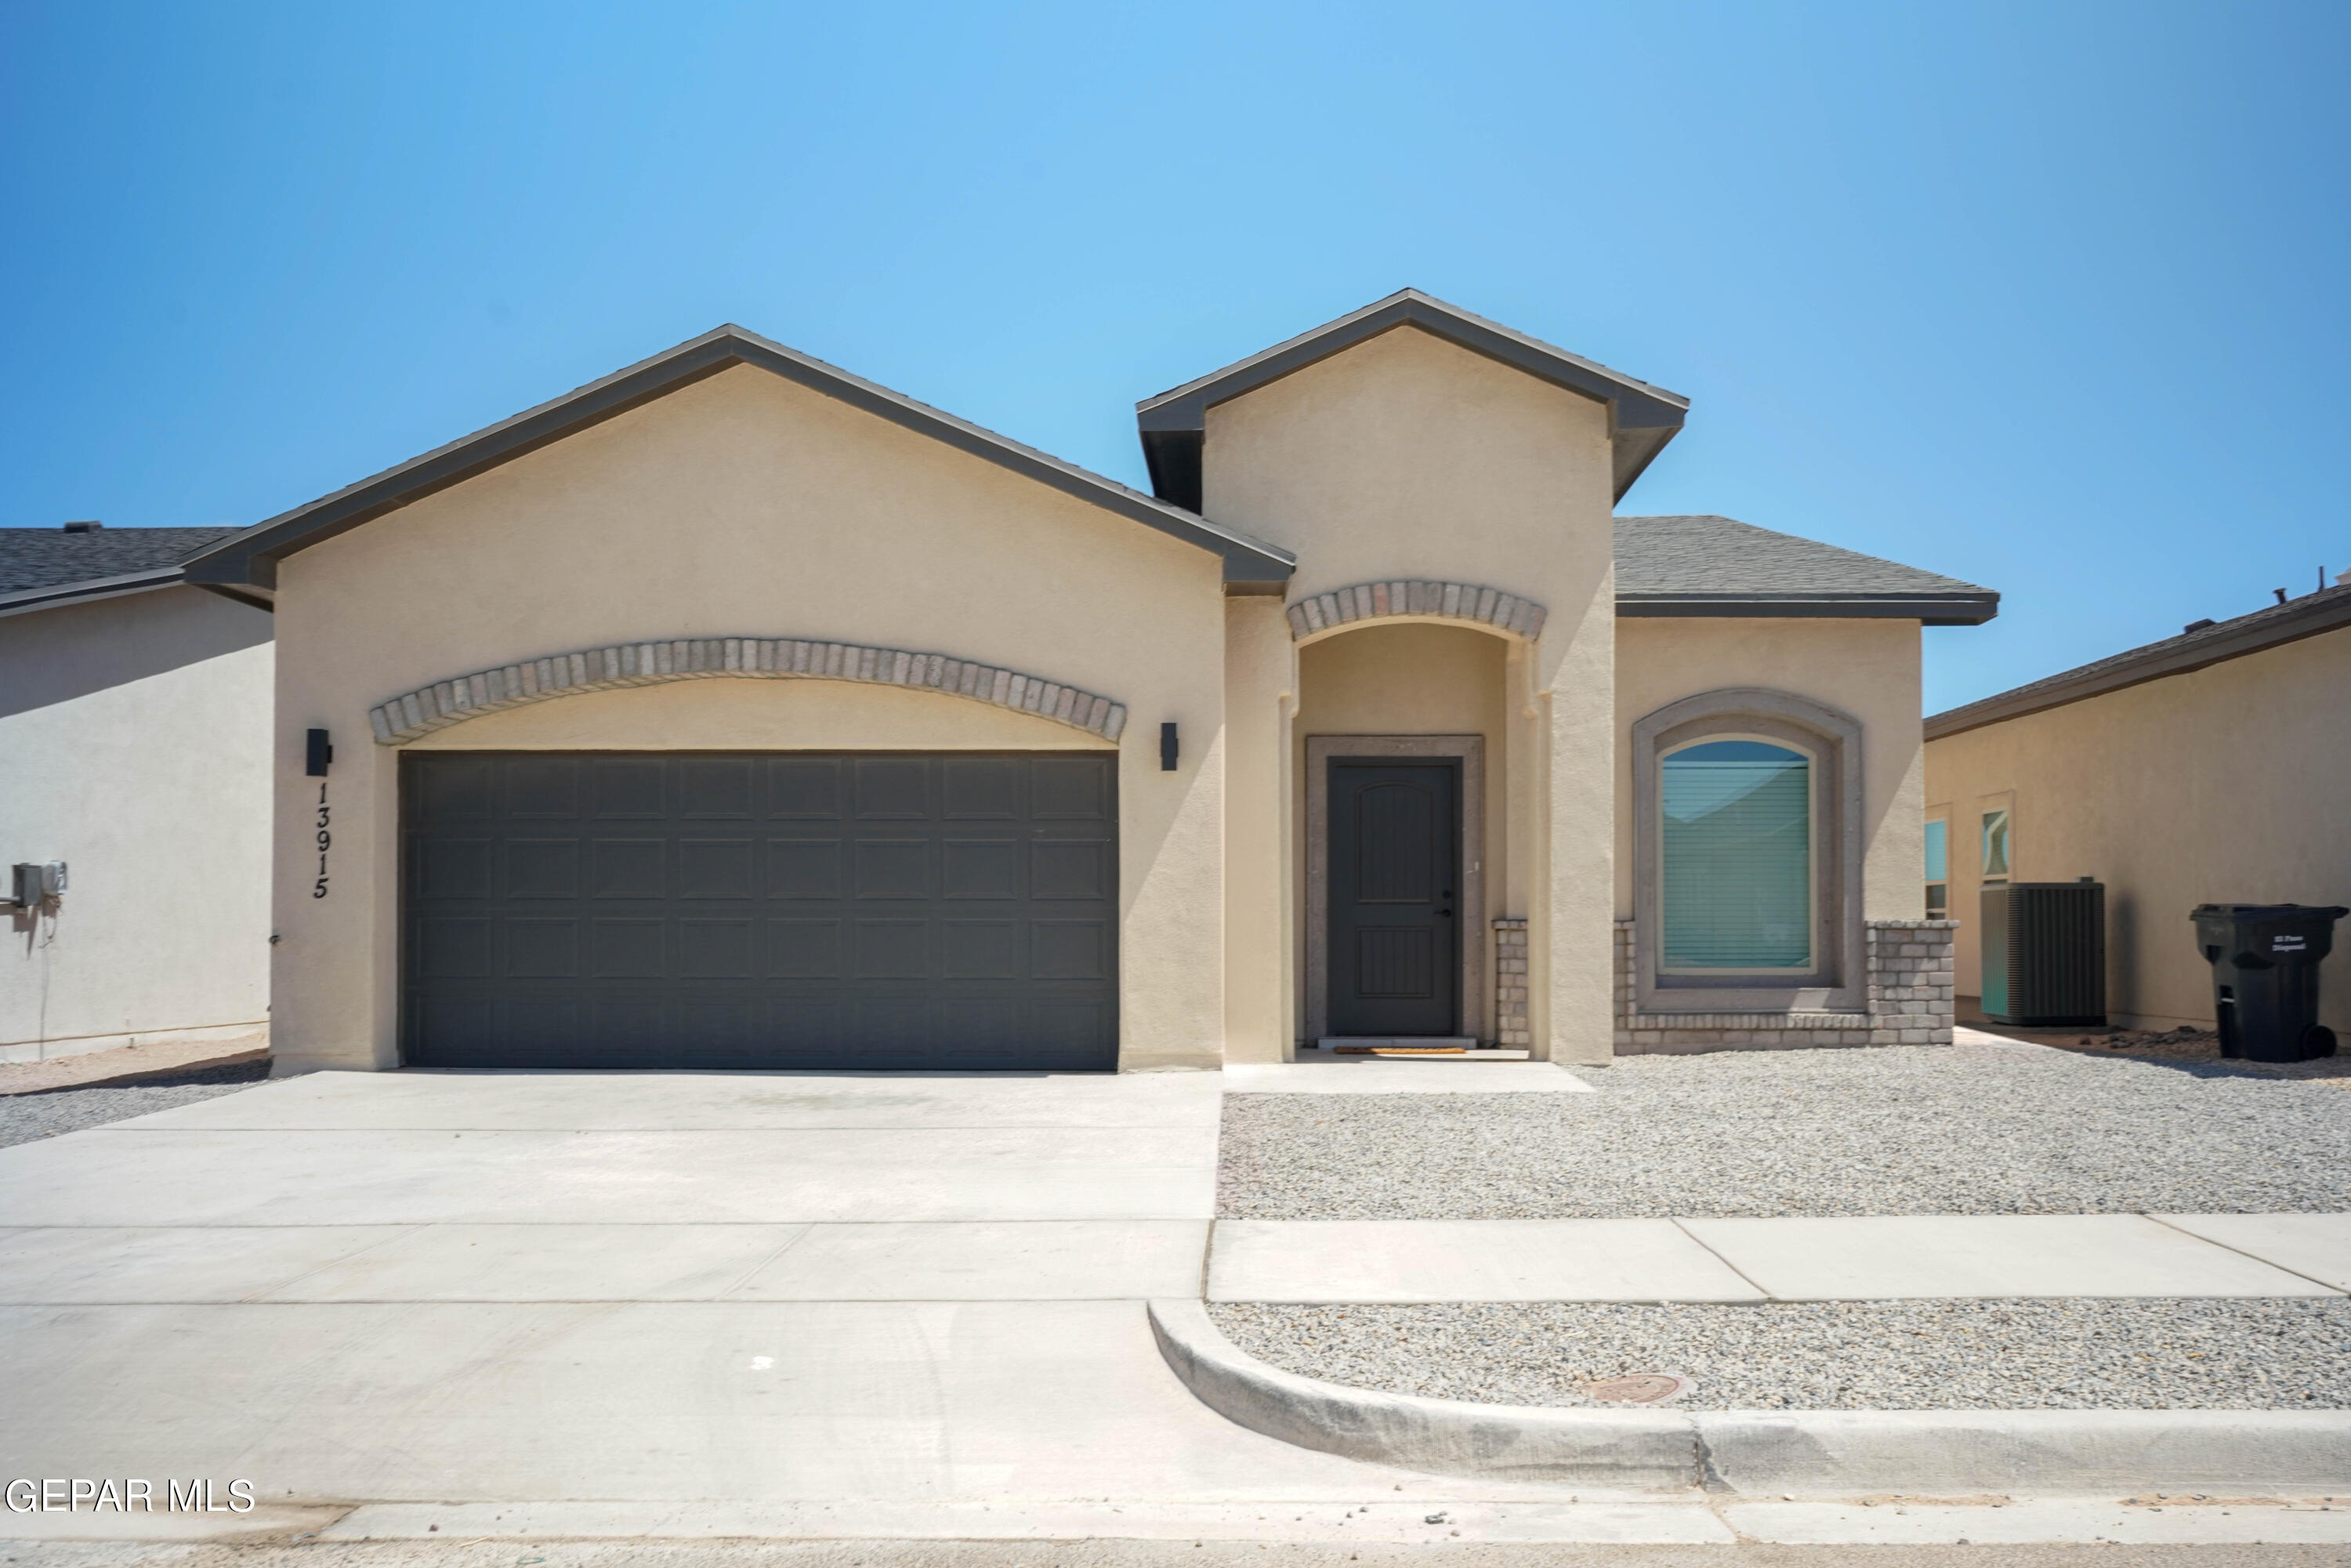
[1632,686,1867,1013]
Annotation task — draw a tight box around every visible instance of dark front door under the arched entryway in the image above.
[1328,757,1462,1037]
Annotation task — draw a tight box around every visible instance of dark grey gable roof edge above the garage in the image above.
[188,324,1298,592]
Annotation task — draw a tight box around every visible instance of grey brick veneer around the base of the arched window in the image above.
[1615,919,1958,1056]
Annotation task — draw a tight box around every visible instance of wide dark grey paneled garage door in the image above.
[400,752,1119,1072]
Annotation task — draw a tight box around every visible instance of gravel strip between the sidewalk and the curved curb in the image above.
[1208,1300,2351,1410]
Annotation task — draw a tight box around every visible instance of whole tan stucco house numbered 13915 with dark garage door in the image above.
[190,292,1996,1072]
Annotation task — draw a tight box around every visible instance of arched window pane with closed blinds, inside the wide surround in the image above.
[1657,741,1815,973]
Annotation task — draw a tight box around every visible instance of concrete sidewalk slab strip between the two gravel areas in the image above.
[1208,1213,2351,1305]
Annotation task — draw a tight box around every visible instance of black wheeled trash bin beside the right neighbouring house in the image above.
[2191,903,2351,1063]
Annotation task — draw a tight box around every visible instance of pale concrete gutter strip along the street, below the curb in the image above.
[13,1490,2351,1568]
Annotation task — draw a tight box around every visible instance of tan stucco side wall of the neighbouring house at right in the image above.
[1925,630,2351,1034]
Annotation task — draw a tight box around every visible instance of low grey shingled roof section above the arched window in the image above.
[1615,515,2001,625]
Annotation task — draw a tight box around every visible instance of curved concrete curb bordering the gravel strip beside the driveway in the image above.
[1150,1300,2351,1495]
